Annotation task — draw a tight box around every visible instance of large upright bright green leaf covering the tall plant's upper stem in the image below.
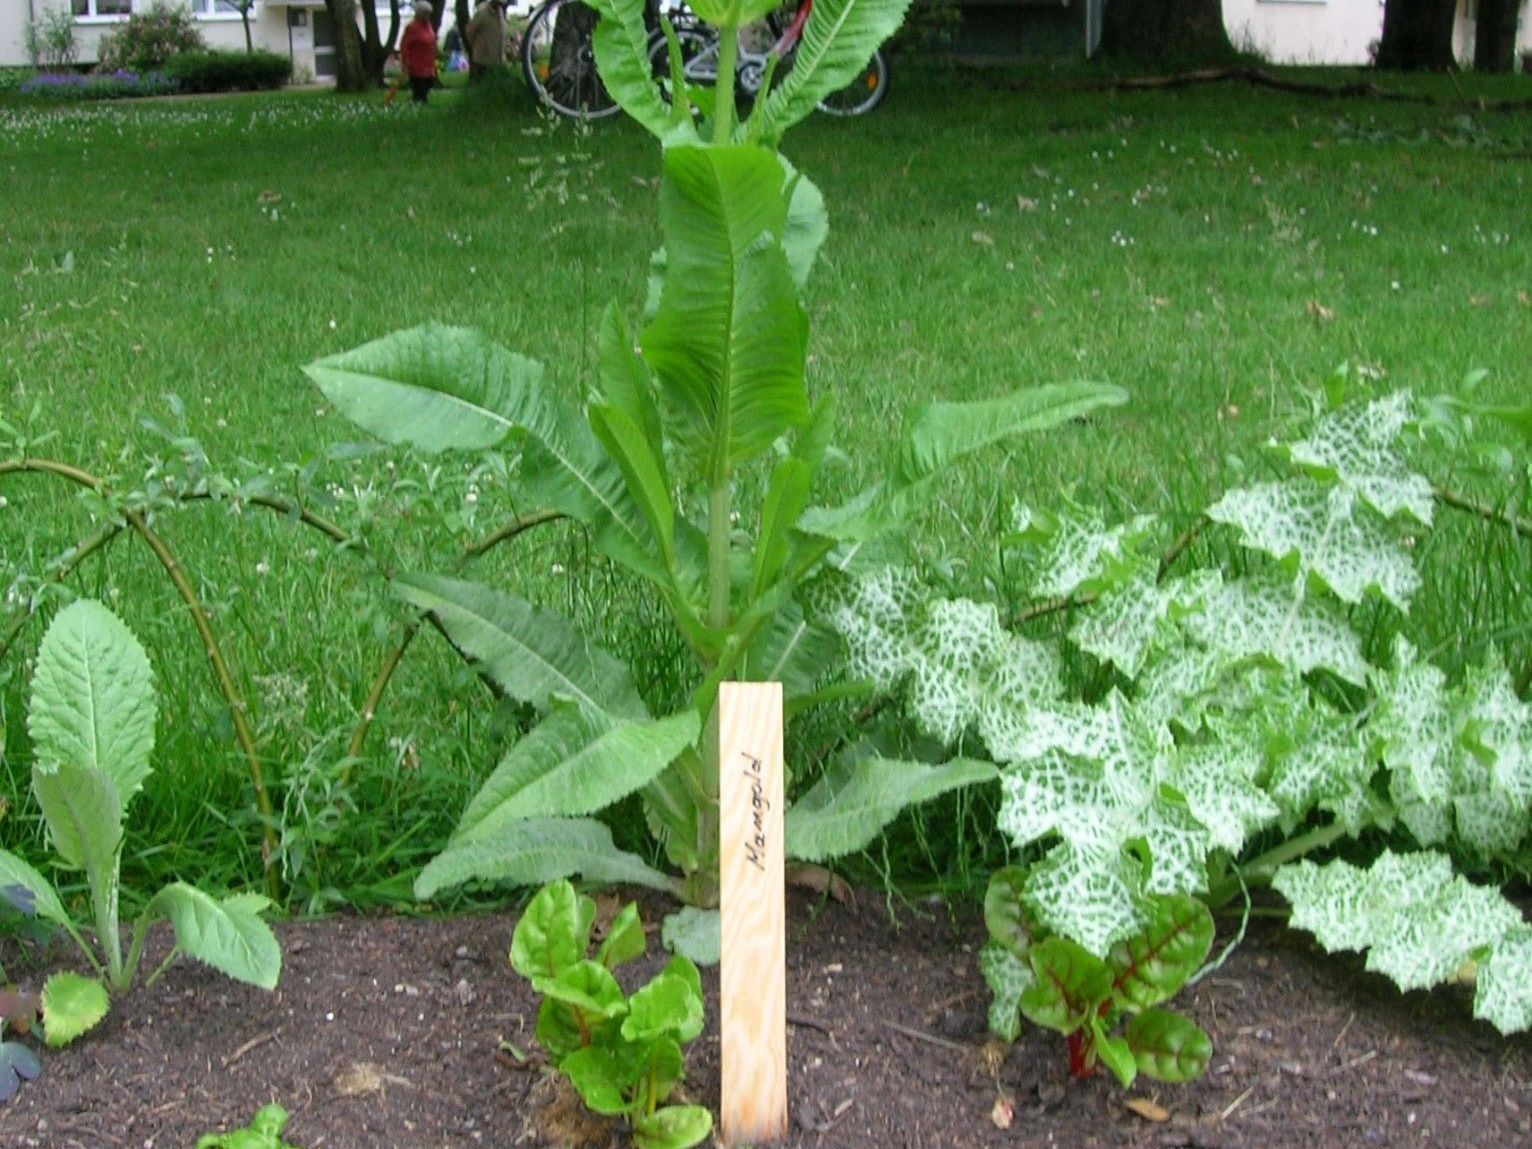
[642,146,809,486]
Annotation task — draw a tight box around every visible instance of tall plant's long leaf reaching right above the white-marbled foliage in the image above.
[800,379,1128,542]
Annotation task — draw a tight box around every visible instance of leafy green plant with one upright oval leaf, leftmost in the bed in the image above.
[0,601,282,1046]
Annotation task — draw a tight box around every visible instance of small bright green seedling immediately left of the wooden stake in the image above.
[510,881,712,1149]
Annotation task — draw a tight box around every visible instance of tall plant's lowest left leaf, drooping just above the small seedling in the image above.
[415,818,677,899]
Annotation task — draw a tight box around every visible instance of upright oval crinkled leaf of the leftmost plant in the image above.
[26,601,155,806]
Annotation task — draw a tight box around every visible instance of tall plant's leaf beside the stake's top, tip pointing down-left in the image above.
[452,703,702,846]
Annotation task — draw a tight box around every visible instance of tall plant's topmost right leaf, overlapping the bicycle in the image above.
[741,0,910,142]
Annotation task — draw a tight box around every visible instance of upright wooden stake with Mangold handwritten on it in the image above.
[719,682,787,1146]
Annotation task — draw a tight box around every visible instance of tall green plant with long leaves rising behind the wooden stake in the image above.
[308,0,1123,925]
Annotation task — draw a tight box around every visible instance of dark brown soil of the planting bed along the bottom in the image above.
[0,895,1532,1149]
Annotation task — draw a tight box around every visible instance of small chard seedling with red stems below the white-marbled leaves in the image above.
[984,867,1213,1088]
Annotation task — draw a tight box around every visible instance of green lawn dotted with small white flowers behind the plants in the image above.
[0,72,1532,908]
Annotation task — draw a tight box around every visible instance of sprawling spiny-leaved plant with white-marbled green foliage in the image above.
[821,388,1532,1033]
